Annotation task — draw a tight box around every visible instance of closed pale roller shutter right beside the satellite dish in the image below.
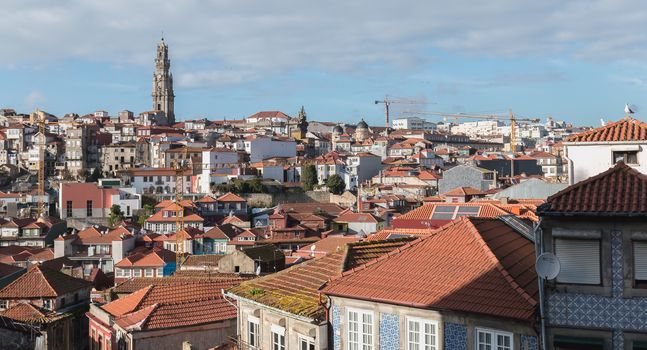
[555,238,600,284]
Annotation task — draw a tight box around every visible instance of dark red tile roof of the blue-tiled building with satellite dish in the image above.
[538,162,647,216]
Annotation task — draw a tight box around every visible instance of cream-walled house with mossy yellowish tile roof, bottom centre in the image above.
[227,240,407,350]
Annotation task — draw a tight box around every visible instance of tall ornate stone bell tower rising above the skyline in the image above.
[152,38,175,125]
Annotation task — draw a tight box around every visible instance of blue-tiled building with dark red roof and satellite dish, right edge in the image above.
[537,163,647,350]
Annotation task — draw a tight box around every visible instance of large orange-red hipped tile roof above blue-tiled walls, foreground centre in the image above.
[322,217,537,320]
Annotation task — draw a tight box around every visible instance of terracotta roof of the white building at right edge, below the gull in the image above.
[566,117,647,142]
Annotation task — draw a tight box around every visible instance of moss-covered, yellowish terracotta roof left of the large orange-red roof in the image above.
[229,242,410,321]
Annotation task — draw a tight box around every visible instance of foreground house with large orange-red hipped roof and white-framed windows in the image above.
[321,218,538,350]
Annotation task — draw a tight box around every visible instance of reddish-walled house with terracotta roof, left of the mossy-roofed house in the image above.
[86,278,236,350]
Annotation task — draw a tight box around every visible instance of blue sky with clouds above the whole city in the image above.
[0,0,647,125]
